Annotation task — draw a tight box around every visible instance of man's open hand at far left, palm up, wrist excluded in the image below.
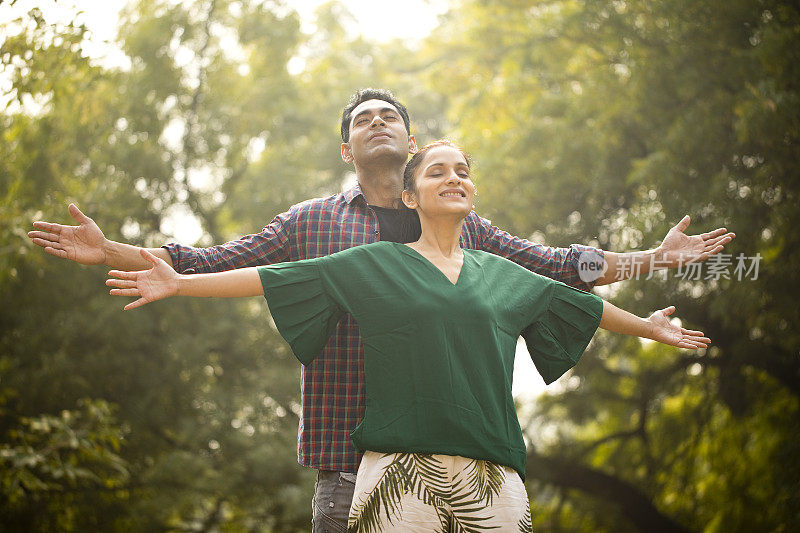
[28,204,106,265]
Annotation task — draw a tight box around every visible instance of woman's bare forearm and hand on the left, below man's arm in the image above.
[106,250,264,311]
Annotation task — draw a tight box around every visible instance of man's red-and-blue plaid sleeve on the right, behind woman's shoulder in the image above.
[467,212,604,290]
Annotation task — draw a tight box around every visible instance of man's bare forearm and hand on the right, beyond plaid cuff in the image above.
[595,215,736,285]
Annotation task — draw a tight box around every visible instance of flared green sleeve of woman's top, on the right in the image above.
[522,283,603,385]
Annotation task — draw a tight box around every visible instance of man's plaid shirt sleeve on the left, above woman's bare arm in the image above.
[162,209,294,274]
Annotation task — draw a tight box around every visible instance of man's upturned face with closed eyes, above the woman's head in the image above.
[342,100,416,166]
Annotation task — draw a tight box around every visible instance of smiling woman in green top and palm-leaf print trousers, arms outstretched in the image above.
[107,141,710,531]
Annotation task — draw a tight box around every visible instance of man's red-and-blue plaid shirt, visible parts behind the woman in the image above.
[164,185,602,472]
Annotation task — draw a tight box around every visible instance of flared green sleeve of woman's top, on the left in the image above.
[258,258,344,365]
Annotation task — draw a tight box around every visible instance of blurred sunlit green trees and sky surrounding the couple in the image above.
[0,0,800,533]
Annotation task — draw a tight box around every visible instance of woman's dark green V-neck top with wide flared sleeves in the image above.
[259,242,603,479]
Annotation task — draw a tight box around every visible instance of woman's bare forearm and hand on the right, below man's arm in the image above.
[600,301,711,350]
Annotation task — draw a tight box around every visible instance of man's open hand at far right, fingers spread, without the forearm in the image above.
[656,215,736,268]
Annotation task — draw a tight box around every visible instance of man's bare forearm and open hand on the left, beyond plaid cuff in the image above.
[28,204,172,270]
